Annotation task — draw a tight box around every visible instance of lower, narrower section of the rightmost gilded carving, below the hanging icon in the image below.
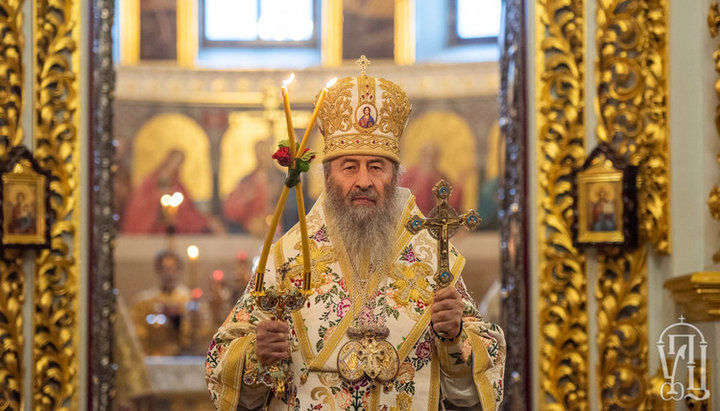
[595,247,649,410]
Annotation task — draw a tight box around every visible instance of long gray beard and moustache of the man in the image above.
[323,179,400,275]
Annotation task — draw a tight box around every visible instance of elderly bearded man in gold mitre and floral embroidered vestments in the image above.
[206,71,505,411]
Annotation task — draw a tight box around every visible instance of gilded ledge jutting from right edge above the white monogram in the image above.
[665,271,720,322]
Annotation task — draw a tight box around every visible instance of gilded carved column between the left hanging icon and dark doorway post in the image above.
[32,0,80,409]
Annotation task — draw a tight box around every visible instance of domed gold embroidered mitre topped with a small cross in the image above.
[318,56,411,163]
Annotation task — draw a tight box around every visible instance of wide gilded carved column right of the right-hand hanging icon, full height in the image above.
[595,0,670,409]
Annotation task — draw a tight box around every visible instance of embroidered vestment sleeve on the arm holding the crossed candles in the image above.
[205,249,275,411]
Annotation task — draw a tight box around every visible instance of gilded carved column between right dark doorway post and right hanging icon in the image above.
[536,0,588,409]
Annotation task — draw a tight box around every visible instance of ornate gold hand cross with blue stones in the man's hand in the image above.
[405,180,481,288]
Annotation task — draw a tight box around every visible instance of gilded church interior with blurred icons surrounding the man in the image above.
[0,0,720,410]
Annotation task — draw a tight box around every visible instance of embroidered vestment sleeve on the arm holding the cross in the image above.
[435,278,506,411]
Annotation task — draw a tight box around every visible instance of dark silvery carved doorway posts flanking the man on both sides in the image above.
[88,0,530,410]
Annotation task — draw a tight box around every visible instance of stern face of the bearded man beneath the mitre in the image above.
[330,155,394,209]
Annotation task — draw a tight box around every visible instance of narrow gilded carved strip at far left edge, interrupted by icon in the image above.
[0,0,25,410]
